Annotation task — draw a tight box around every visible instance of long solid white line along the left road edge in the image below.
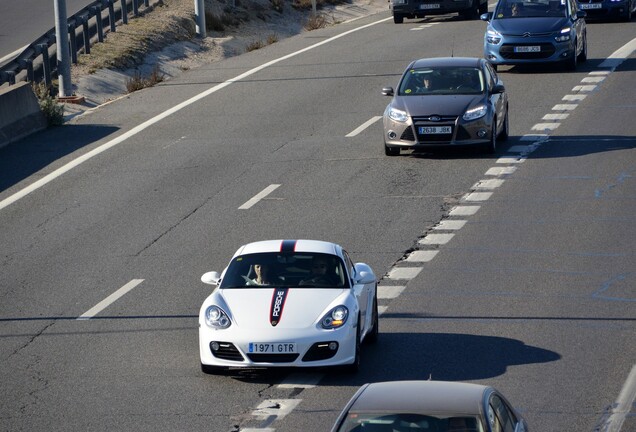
[0,17,392,210]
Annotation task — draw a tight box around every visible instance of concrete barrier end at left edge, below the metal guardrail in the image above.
[0,82,47,147]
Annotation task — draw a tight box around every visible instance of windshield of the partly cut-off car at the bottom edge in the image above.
[338,412,484,432]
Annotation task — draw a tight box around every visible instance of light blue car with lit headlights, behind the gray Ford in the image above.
[481,0,587,70]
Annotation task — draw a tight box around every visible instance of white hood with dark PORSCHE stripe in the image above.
[220,288,348,329]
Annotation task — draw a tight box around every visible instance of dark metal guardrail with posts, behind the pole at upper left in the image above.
[0,0,154,86]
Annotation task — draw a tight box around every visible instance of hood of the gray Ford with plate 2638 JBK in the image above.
[393,94,484,117]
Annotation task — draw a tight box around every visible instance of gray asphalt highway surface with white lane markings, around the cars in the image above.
[0,5,636,432]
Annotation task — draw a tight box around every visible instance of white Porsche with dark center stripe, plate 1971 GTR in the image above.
[199,240,378,373]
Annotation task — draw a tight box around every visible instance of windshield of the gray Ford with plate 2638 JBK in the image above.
[398,67,486,96]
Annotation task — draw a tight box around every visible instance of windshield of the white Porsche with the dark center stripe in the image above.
[220,252,350,288]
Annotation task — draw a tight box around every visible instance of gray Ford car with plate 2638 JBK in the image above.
[382,57,509,156]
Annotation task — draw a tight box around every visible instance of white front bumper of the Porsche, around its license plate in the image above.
[199,324,356,368]
